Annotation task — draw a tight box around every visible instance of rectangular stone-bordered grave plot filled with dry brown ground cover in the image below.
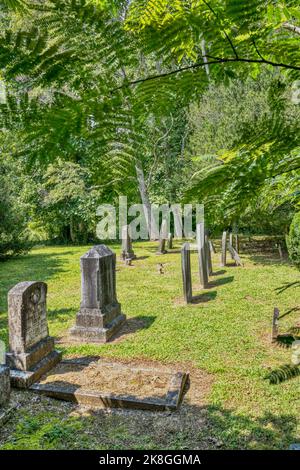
[30,358,188,411]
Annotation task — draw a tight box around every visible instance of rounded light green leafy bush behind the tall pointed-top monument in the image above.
[27,161,101,243]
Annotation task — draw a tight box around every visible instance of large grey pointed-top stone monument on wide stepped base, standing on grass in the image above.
[70,245,126,343]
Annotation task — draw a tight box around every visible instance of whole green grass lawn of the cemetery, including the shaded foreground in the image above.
[0,242,300,449]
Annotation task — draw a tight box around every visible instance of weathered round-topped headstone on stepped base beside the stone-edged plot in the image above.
[6,281,61,388]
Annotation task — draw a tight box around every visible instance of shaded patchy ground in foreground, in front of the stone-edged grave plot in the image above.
[0,396,298,450]
